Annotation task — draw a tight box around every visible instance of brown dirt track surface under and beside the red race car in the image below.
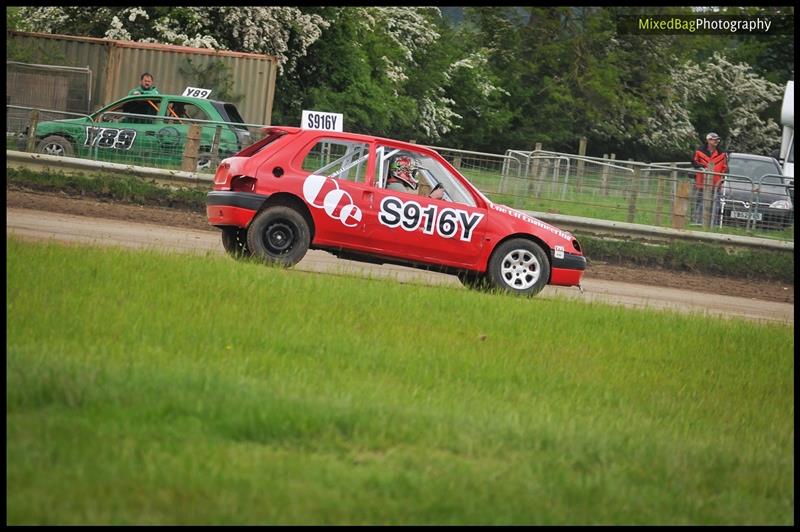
[6,189,794,323]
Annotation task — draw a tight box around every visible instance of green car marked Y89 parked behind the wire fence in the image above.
[25,94,251,169]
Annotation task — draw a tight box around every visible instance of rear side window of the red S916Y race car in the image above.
[302,138,369,183]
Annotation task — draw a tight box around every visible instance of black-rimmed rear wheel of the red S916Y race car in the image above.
[247,205,311,268]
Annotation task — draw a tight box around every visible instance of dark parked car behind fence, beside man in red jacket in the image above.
[720,153,794,229]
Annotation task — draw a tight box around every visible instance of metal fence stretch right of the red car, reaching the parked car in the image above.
[488,150,794,235]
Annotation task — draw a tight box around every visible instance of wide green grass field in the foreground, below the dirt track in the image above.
[6,238,794,524]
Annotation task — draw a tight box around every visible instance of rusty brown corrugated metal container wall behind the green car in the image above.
[6,31,278,124]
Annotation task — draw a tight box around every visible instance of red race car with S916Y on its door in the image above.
[206,126,586,296]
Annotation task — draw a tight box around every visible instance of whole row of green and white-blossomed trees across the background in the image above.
[14,6,794,161]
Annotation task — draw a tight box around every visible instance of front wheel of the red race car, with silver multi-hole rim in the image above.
[486,238,550,297]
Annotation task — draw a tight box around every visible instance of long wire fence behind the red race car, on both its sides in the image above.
[6,105,794,239]
